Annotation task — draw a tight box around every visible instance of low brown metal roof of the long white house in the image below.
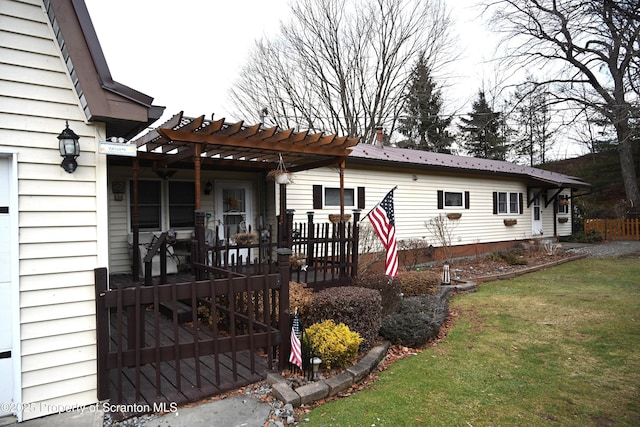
[349,144,591,188]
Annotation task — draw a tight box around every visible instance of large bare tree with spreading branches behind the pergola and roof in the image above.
[231,0,454,142]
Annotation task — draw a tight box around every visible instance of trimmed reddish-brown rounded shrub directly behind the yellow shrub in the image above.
[307,286,382,350]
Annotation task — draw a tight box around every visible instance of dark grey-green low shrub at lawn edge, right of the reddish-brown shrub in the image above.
[380,289,451,347]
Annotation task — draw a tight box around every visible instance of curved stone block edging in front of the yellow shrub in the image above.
[267,342,390,407]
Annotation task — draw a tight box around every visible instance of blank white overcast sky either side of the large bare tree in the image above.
[85,0,584,159]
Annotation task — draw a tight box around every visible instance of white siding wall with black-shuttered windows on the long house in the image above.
[287,166,571,246]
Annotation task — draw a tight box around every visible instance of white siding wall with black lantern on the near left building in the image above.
[0,0,107,420]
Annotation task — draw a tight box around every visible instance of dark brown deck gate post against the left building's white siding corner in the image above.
[93,267,110,400]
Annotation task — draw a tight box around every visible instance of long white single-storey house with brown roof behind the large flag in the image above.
[287,135,591,264]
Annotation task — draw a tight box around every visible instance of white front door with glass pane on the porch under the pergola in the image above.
[215,181,253,260]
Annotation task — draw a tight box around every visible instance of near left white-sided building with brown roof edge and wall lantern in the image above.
[0,0,163,421]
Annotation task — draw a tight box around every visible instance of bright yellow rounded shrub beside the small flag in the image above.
[306,320,362,369]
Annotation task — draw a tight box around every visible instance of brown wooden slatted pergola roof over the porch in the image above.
[132,112,360,172]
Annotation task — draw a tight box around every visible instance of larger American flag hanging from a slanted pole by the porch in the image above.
[369,188,398,277]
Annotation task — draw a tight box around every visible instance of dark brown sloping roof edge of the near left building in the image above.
[45,0,164,139]
